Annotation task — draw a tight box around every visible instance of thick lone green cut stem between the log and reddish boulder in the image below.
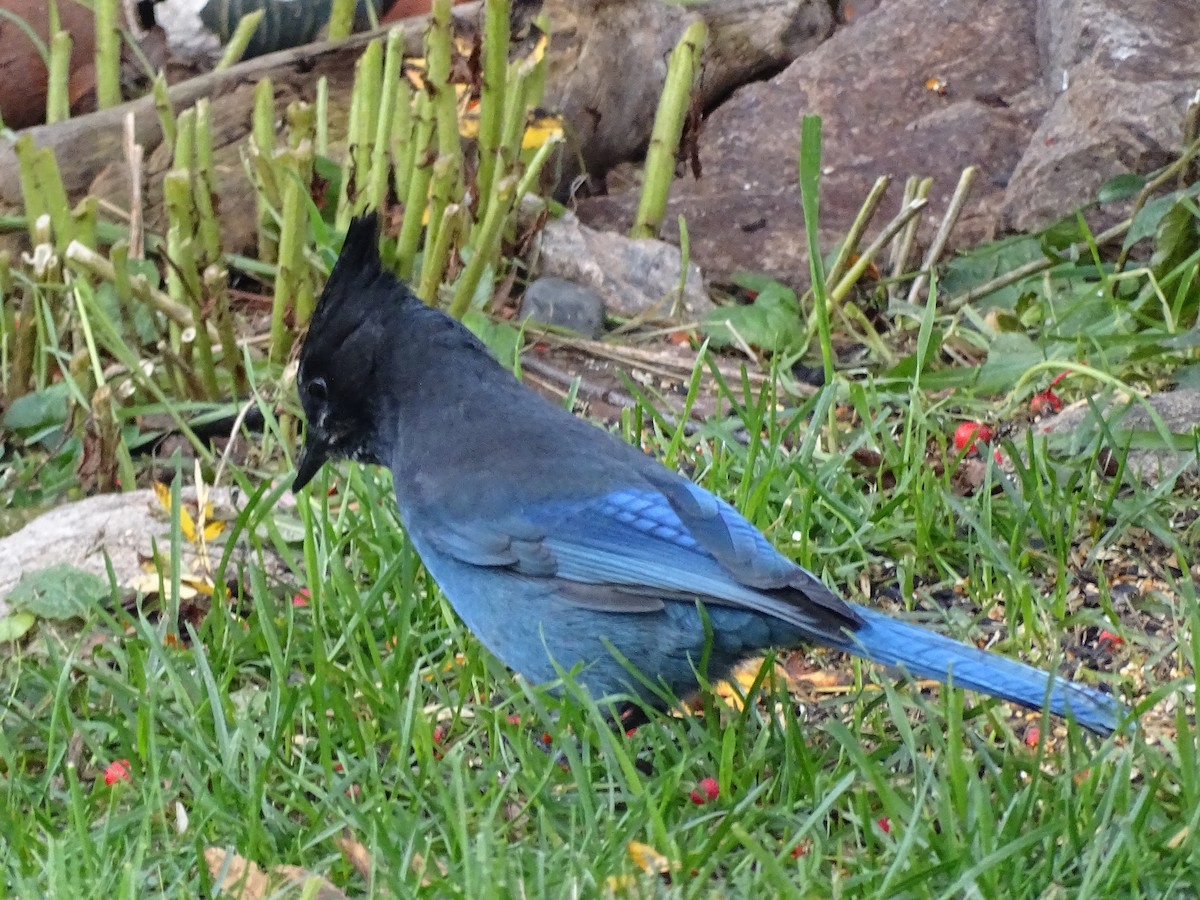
[630,22,708,238]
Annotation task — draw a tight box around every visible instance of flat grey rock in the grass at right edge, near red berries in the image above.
[1036,388,1200,484]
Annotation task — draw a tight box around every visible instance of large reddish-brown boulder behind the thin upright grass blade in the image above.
[578,0,1042,284]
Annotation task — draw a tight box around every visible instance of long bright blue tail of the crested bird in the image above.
[824,604,1124,734]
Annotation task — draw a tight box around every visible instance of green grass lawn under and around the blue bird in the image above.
[0,364,1200,896]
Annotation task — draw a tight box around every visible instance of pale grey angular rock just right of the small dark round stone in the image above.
[533,214,713,320]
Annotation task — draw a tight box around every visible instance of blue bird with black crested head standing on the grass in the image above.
[293,212,1124,736]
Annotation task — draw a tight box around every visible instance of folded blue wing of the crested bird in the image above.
[424,476,859,636]
